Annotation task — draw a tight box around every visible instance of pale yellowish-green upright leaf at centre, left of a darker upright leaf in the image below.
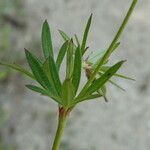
[66,39,74,79]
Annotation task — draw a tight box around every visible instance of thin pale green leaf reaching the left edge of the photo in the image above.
[0,62,35,79]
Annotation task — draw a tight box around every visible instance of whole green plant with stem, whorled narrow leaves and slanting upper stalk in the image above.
[0,0,137,150]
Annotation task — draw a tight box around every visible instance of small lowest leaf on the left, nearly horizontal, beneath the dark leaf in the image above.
[26,85,62,104]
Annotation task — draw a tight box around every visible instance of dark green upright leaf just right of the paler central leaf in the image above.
[72,46,82,93]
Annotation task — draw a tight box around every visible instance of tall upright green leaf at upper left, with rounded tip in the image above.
[42,20,53,58]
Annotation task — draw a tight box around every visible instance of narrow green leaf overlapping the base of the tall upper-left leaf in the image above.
[48,56,62,96]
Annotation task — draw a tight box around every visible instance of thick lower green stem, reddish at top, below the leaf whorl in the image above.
[52,108,68,150]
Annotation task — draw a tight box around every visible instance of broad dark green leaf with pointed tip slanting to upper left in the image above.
[25,50,52,90]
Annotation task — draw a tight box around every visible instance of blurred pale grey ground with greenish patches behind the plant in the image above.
[0,0,150,150]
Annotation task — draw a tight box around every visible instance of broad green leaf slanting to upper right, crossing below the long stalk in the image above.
[79,61,124,97]
